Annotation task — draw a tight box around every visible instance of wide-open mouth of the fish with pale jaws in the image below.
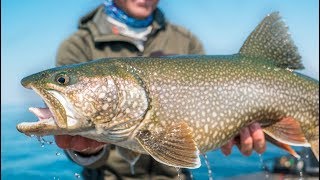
[17,87,78,135]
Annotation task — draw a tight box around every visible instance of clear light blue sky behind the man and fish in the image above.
[1,0,319,106]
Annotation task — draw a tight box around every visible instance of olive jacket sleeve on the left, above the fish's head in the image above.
[56,34,92,66]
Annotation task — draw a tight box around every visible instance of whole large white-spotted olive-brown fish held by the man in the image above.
[17,12,319,168]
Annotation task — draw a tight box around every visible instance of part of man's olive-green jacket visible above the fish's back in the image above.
[56,7,204,65]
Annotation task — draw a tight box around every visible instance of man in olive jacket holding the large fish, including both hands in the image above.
[55,0,265,178]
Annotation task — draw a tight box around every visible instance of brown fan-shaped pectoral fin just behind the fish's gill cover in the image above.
[136,122,201,168]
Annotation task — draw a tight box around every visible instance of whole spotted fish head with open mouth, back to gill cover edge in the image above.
[17,60,148,142]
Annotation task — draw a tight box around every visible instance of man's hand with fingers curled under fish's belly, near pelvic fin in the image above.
[221,123,266,156]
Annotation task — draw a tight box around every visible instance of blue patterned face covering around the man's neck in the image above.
[104,0,153,28]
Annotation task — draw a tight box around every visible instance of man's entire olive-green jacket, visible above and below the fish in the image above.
[56,6,204,179]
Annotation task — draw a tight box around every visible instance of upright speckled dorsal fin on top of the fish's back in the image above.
[239,12,304,69]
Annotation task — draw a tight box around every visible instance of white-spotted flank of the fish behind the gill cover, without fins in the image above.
[112,55,319,152]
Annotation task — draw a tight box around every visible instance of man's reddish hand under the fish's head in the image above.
[54,135,106,154]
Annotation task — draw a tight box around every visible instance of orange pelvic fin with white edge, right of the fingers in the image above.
[263,117,310,158]
